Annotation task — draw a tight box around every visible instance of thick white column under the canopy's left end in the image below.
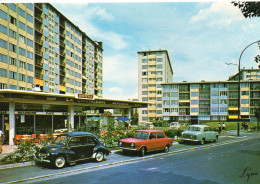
[9,102,15,146]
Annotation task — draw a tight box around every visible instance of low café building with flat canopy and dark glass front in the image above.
[0,90,148,145]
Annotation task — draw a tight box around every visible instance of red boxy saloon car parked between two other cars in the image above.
[119,130,173,156]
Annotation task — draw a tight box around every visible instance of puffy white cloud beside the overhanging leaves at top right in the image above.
[190,2,244,26]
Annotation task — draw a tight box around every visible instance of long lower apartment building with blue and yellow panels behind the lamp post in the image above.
[162,69,260,123]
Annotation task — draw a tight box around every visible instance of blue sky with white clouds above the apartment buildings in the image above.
[51,1,260,100]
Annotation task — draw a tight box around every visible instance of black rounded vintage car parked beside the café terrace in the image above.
[35,132,110,168]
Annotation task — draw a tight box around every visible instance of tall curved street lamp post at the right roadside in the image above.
[226,40,260,136]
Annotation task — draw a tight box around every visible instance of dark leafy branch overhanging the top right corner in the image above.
[232,1,260,18]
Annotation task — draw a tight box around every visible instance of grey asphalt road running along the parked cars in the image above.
[0,134,260,184]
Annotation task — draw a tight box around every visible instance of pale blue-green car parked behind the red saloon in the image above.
[182,125,218,144]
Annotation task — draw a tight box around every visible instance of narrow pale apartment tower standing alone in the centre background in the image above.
[138,50,173,122]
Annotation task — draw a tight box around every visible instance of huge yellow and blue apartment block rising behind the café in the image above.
[0,3,103,97]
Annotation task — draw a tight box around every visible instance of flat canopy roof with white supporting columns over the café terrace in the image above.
[0,89,148,145]
